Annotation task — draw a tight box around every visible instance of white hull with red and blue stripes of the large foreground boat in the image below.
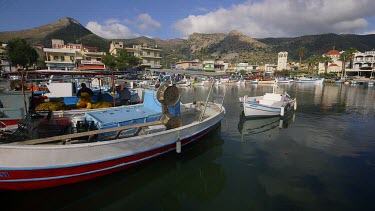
[0,103,225,190]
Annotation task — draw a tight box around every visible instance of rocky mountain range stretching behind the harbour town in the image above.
[0,18,375,64]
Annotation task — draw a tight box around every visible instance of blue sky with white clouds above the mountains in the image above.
[0,0,375,39]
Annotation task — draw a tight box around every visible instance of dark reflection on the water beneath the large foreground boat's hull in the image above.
[2,127,226,210]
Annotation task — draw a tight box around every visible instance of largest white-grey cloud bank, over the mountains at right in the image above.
[174,0,375,38]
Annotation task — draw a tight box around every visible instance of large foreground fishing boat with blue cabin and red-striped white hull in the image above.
[0,83,225,190]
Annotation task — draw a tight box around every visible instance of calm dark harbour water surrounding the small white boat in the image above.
[0,84,375,210]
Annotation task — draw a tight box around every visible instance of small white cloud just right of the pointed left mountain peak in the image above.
[86,21,139,39]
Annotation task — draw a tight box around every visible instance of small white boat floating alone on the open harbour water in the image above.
[239,92,297,117]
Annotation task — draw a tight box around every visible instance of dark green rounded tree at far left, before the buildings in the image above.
[7,38,39,69]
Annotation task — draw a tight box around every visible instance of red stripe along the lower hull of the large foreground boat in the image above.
[0,125,216,190]
